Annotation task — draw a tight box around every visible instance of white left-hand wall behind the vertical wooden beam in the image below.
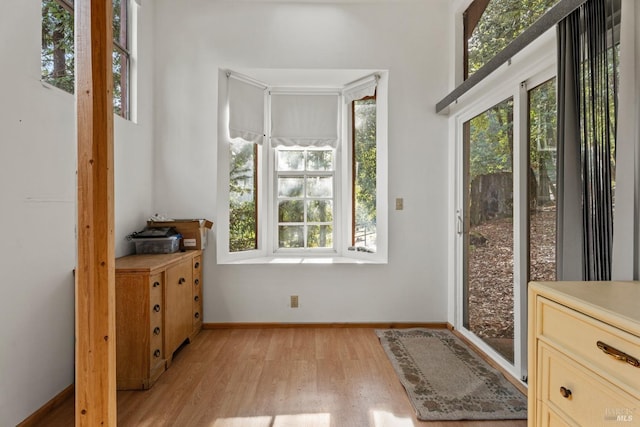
[0,0,153,426]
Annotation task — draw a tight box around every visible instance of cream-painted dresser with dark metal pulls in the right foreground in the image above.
[528,282,640,427]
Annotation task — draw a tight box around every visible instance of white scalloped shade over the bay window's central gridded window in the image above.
[271,92,339,148]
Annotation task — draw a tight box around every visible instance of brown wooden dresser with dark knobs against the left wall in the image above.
[116,250,202,390]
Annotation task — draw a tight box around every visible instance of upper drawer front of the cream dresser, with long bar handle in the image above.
[538,298,640,398]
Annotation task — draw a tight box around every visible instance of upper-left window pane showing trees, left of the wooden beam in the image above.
[41,0,75,93]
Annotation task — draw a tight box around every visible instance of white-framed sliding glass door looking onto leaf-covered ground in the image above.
[457,78,557,379]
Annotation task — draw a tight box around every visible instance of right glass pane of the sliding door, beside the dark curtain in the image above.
[529,79,557,280]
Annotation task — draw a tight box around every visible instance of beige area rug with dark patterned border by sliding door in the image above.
[376,329,527,421]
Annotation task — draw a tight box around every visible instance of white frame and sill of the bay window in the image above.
[216,70,388,264]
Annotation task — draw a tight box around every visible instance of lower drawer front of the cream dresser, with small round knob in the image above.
[538,344,638,426]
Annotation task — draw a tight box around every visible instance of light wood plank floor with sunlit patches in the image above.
[36,328,526,427]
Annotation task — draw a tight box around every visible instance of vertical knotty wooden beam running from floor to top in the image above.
[75,0,116,426]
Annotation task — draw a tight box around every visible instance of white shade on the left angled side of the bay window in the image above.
[228,74,266,144]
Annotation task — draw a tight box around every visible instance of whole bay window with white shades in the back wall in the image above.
[217,70,387,263]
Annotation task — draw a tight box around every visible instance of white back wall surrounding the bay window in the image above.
[154,0,450,323]
